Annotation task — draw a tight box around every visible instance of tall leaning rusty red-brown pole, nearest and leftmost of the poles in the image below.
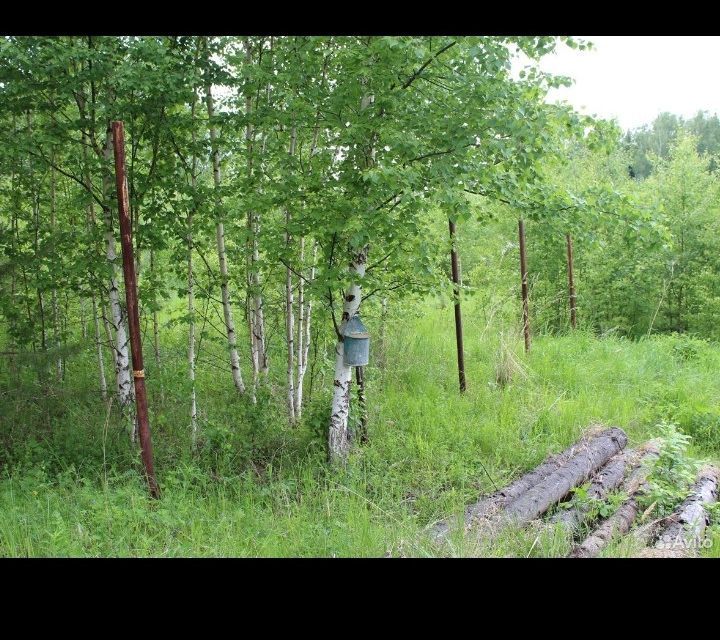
[112,120,160,498]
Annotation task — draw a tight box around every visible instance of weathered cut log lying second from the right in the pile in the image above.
[568,442,659,558]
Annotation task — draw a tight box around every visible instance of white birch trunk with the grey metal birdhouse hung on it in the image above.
[328,249,367,464]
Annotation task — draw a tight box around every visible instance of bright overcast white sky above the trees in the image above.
[541,36,720,129]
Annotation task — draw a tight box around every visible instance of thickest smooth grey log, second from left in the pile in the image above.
[501,427,627,526]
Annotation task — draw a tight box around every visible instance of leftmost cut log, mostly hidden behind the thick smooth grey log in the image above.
[430,429,627,541]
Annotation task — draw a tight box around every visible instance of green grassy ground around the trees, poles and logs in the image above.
[0,292,720,556]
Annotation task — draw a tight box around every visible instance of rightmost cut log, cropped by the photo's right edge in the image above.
[641,467,720,557]
